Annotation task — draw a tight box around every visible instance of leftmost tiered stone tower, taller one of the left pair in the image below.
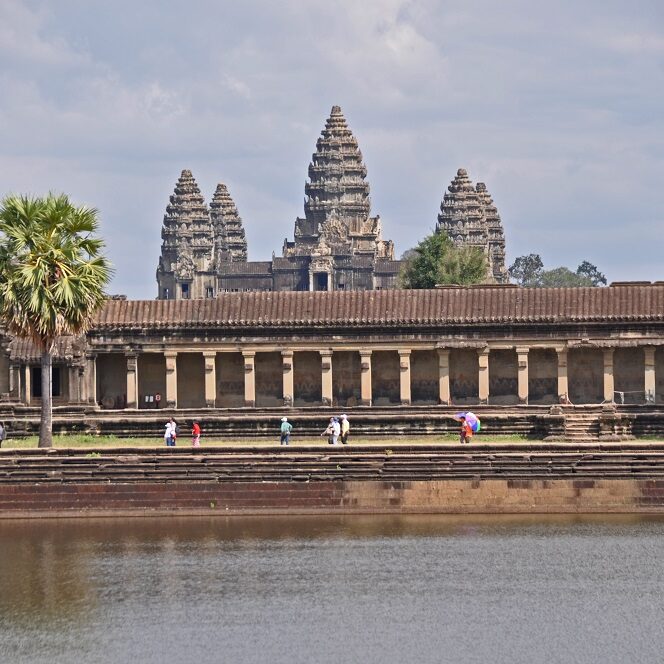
[157,170,214,300]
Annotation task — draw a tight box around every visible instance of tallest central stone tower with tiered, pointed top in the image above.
[277,106,394,290]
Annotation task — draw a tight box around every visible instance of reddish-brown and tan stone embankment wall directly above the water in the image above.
[0,479,664,518]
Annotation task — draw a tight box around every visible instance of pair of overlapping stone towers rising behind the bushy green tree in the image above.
[436,168,507,283]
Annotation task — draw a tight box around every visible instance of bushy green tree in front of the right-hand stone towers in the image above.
[399,233,489,288]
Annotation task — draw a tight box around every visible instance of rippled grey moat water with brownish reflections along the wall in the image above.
[0,516,664,664]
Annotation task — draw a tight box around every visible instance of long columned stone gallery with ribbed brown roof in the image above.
[0,283,664,411]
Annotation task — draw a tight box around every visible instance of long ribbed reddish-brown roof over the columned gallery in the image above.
[94,283,664,330]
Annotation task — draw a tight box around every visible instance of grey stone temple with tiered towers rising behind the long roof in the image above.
[157,106,507,299]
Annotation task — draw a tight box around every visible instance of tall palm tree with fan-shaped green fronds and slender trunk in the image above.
[0,194,111,447]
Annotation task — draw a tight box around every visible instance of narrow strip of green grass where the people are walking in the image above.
[2,434,532,449]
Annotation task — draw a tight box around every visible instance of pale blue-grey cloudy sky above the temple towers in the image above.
[0,0,664,299]
